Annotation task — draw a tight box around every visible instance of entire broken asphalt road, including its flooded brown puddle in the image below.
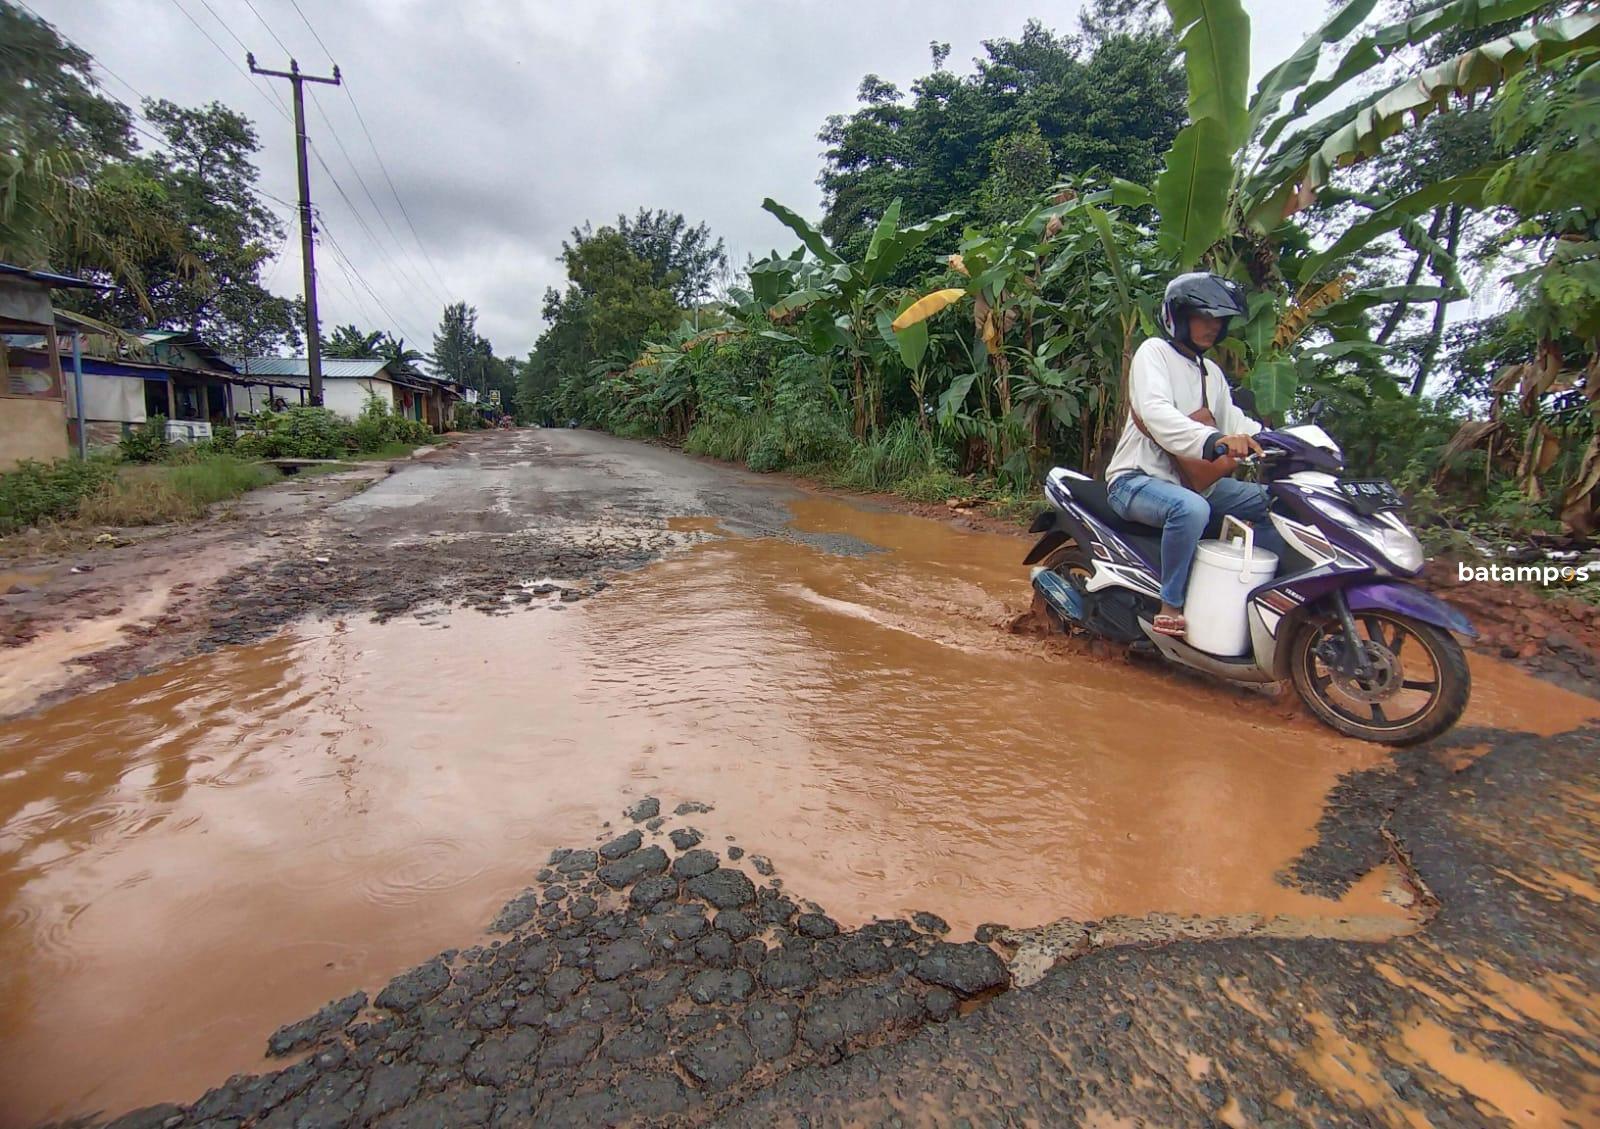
[0,430,1600,1126]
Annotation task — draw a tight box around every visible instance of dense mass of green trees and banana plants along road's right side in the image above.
[520,0,1600,543]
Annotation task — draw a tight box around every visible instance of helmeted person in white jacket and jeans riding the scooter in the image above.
[1106,272,1283,635]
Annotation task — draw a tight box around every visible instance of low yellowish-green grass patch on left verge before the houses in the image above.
[72,454,282,526]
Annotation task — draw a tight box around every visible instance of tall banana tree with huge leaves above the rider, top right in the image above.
[1154,0,1600,409]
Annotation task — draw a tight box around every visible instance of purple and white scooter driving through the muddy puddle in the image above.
[1024,416,1477,745]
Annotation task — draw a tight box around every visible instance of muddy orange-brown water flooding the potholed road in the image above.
[0,499,1600,1124]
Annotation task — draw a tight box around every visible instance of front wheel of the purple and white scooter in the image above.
[1290,611,1472,745]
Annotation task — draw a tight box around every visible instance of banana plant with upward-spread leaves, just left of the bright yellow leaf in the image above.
[750,198,957,438]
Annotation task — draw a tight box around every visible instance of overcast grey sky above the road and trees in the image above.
[27,0,1322,355]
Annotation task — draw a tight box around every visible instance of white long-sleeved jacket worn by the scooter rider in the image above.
[1106,337,1261,485]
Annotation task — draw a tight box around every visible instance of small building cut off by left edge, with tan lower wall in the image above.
[0,262,91,470]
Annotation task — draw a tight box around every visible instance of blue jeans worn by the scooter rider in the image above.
[1106,470,1283,608]
